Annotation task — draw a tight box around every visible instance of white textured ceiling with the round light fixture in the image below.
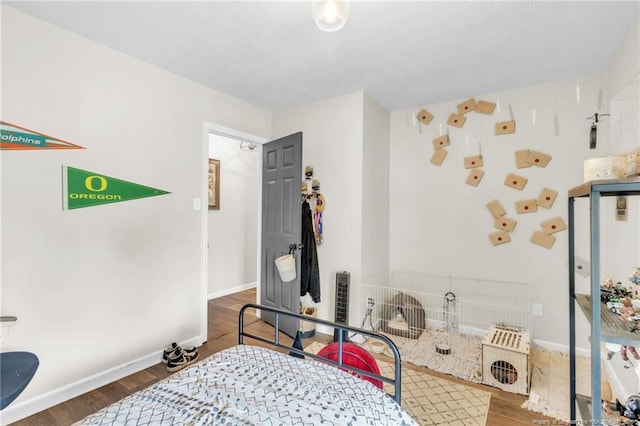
[3,1,640,111]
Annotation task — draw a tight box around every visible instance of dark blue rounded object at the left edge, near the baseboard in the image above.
[0,352,40,410]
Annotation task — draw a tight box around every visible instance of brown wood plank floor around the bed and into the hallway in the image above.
[13,290,553,426]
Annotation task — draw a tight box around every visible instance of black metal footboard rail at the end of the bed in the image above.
[238,303,402,404]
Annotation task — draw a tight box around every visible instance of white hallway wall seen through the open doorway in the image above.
[208,134,260,298]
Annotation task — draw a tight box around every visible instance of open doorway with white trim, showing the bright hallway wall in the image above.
[202,122,268,342]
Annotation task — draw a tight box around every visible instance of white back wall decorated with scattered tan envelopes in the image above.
[390,75,607,344]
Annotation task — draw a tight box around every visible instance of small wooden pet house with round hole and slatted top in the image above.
[482,326,531,395]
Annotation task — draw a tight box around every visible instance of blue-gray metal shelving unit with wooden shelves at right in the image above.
[568,178,640,424]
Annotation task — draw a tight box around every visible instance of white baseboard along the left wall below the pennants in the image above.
[0,336,206,425]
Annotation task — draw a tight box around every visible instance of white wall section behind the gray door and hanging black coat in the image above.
[272,92,363,326]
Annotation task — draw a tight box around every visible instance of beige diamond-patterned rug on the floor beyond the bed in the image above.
[305,342,491,426]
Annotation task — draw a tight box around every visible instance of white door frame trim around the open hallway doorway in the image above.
[201,121,269,342]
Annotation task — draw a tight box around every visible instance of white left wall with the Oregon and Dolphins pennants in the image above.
[1,5,270,423]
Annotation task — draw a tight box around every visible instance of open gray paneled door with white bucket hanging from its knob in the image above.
[260,132,302,337]
